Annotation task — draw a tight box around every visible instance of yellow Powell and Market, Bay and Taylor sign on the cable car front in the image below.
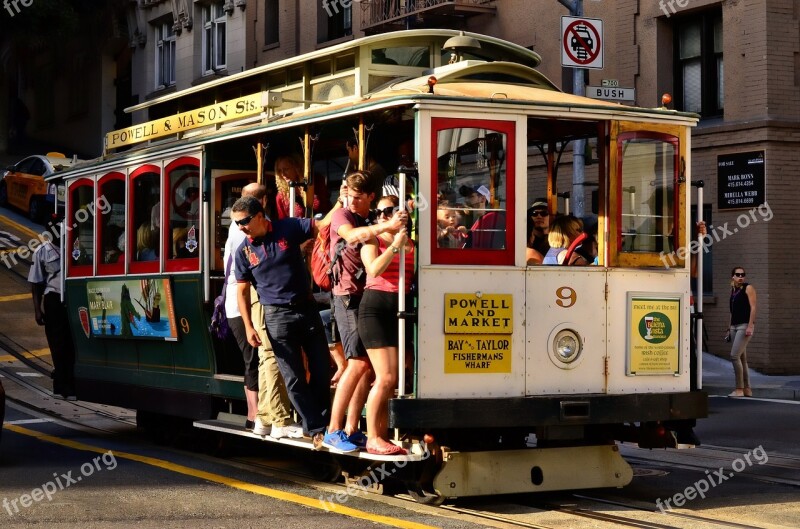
[444,294,514,374]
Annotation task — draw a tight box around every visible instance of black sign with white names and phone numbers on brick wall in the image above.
[717,151,766,209]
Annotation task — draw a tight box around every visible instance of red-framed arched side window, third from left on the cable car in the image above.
[128,165,161,273]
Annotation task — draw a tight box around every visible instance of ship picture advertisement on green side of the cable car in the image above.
[82,278,178,341]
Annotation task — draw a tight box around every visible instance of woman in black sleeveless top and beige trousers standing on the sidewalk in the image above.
[725,266,756,397]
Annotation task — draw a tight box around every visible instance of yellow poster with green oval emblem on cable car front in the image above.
[627,293,681,375]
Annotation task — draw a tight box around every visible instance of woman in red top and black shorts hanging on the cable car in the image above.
[358,195,414,455]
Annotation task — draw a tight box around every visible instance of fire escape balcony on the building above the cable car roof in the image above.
[361,0,497,35]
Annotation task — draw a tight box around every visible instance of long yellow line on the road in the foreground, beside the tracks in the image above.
[3,424,436,529]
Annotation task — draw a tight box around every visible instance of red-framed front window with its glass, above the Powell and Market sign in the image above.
[432,119,514,264]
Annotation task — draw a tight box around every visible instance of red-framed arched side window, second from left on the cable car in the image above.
[96,172,125,275]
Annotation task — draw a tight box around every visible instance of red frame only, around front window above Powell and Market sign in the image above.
[428,118,517,265]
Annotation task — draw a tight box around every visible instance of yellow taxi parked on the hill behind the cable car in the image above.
[0,152,79,222]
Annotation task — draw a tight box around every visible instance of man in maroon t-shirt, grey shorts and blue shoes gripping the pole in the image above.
[323,171,408,452]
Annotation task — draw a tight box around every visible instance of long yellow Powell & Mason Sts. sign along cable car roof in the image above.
[106,92,268,150]
